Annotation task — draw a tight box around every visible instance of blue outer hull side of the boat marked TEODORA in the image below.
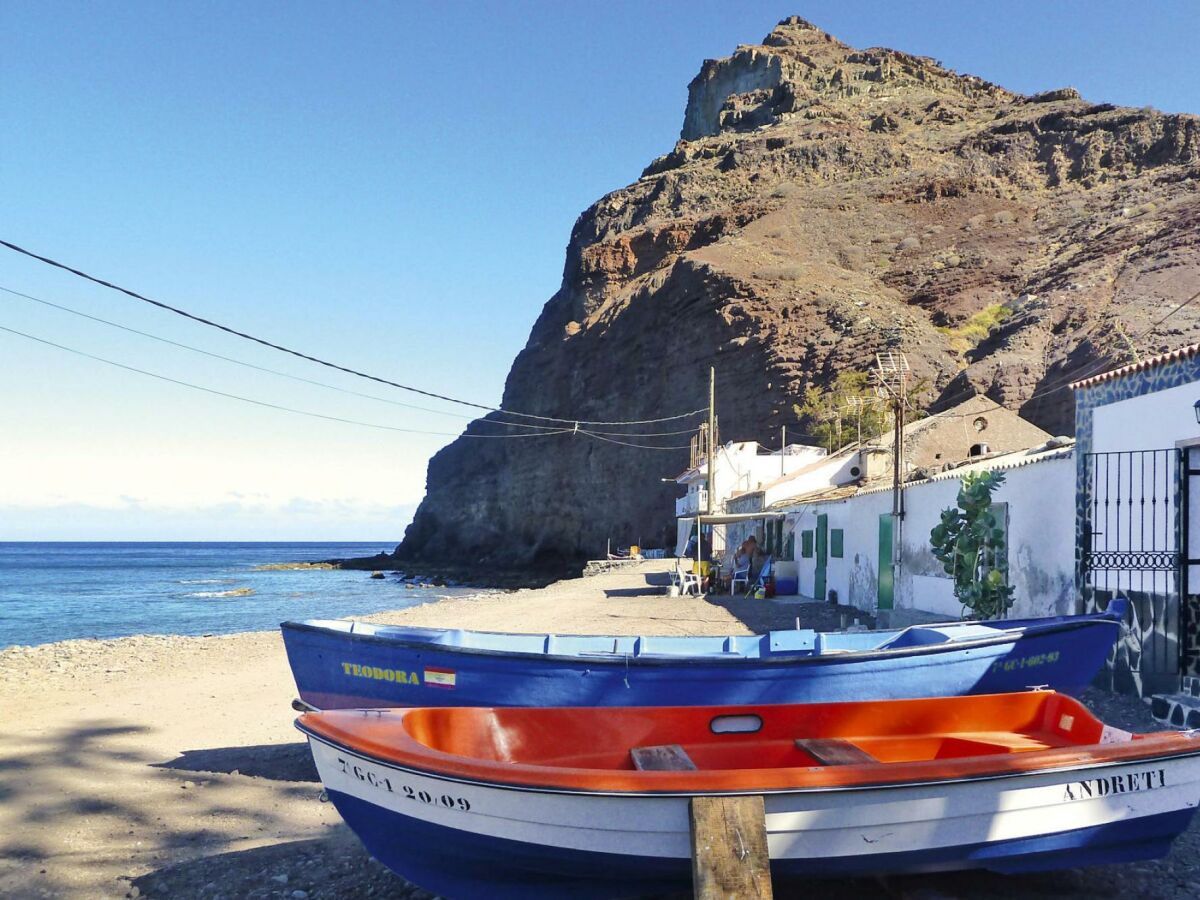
[283,617,1120,709]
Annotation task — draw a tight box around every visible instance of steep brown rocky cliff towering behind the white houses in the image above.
[398,18,1200,565]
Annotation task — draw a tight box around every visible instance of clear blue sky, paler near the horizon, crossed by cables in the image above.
[0,0,1200,540]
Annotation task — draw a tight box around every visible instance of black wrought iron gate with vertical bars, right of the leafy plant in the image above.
[1079,448,1188,696]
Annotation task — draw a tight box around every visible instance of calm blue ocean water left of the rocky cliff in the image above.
[0,541,472,648]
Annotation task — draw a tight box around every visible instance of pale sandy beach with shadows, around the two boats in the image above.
[7,562,1200,900]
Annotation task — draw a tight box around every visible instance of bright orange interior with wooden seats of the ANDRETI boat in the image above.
[300,691,1133,772]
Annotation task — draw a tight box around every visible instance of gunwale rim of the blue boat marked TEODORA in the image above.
[280,613,1121,667]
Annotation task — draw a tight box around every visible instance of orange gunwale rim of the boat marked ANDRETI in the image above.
[294,716,1200,805]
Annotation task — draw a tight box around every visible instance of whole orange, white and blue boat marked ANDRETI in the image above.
[298,691,1200,898]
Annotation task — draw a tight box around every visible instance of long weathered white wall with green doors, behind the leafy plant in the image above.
[791,456,1076,620]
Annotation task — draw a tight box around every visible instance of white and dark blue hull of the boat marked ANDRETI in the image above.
[308,733,1200,898]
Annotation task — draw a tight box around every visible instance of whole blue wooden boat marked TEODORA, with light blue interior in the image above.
[281,599,1127,709]
